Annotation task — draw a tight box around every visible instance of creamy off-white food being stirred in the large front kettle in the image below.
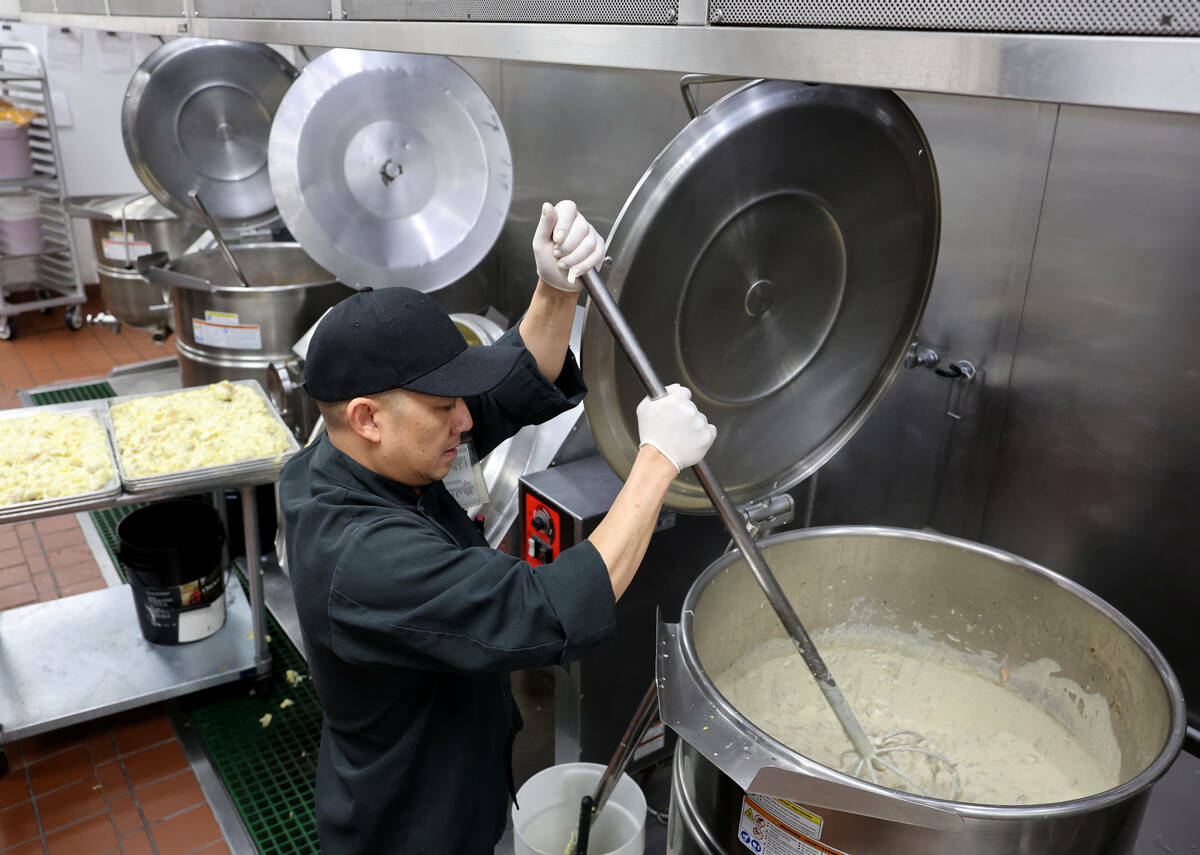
[716,627,1121,805]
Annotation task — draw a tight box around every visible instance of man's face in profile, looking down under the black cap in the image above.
[377,389,472,486]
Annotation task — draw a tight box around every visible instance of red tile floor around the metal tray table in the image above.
[0,288,229,855]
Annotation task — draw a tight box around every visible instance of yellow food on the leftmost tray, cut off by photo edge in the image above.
[0,413,115,506]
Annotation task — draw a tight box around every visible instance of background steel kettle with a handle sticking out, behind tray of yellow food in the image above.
[148,244,353,385]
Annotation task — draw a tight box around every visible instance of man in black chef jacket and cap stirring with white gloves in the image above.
[280,202,715,855]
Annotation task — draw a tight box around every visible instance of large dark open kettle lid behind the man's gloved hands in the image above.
[582,80,940,512]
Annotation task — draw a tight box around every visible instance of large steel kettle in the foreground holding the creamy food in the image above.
[658,527,1186,855]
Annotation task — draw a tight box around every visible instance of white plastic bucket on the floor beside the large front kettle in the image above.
[512,763,646,855]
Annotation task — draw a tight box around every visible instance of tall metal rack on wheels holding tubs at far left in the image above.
[0,42,88,340]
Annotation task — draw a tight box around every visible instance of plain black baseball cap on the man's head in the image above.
[304,288,522,402]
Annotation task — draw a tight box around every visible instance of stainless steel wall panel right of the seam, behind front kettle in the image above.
[983,108,1200,724]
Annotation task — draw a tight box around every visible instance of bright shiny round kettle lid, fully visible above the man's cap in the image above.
[270,49,512,292]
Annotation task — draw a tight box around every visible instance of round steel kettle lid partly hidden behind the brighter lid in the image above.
[121,38,296,228]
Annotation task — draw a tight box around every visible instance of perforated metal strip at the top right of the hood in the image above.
[708,0,1200,36]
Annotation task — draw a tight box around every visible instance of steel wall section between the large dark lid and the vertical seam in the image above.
[815,94,1057,537]
